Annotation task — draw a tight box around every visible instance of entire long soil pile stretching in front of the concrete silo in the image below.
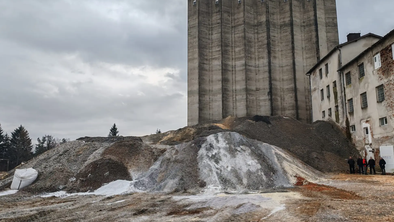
[0,117,357,193]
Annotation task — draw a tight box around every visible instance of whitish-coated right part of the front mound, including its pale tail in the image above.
[198,132,321,192]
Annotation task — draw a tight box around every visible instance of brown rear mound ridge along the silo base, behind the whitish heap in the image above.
[144,116,359,172]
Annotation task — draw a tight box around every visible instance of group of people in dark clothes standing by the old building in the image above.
[347,157,386,175]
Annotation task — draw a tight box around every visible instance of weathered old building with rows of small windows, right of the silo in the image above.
[308,30,394,162]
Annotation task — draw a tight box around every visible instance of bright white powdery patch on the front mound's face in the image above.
[198,133,265,190]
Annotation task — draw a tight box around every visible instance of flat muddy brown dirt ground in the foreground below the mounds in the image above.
[0,174,394,221]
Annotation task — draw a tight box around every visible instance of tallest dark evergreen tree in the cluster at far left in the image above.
[9,125,33,168]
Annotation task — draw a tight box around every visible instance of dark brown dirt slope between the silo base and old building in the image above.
[233,117,359,172]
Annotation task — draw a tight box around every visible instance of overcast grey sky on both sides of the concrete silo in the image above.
[0,0,394,142]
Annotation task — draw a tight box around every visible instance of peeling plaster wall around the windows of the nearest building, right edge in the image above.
[343,33,394,154]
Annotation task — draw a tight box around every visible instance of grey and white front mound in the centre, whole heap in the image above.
[133,132,322,192]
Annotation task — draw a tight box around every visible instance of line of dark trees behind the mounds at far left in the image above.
[0,125,68,171]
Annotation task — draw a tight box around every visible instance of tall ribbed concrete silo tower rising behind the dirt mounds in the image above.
[188,0,338,125]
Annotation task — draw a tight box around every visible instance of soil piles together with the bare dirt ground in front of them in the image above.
[0,116,384,221]
